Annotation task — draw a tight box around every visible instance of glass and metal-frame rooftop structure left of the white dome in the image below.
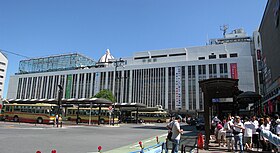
[19,53,95,74]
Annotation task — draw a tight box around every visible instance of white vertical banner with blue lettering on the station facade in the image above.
[175,66,182,109]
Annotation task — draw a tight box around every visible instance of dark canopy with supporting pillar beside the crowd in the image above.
[199,78,239,149]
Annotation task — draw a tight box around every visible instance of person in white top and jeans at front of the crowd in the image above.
[232,116,245,153]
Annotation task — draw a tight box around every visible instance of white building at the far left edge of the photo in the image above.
[0,52,8,98]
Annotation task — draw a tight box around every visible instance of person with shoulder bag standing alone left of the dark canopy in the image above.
[166,115,183,153]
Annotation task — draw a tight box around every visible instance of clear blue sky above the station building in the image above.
[0,0,267,96]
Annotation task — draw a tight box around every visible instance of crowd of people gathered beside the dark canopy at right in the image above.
[212,114,280,152]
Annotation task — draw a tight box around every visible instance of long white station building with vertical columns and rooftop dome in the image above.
[7,29,258,113]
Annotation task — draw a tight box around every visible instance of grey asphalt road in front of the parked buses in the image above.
[0,122,196,153]
